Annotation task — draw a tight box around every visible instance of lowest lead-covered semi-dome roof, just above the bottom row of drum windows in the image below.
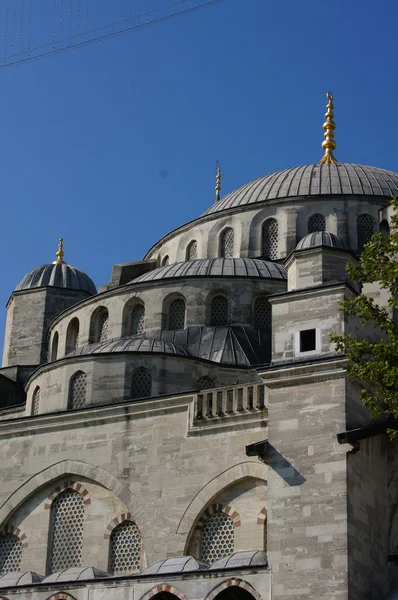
[68,334,188,356]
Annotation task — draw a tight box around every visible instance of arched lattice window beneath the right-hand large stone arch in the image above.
[202,512,234,565]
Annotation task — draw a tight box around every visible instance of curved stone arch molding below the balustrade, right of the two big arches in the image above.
[176,461,267,535]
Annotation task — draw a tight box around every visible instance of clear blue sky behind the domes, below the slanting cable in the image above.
[0,0,398,346]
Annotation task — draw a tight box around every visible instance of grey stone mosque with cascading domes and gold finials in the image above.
[0,94,398,600]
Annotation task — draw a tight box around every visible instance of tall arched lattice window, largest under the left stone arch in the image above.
[48,488,84,573]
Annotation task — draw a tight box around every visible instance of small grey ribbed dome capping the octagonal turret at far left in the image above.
[15,263,97,294]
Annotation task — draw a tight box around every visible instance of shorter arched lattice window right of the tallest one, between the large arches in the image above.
[109,521,142,575]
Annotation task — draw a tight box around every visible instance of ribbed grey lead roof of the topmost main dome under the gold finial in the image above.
[204,163,398,215]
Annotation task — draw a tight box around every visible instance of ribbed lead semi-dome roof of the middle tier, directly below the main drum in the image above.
[131,258,286,283]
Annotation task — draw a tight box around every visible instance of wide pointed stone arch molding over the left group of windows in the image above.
[0,460,143,528]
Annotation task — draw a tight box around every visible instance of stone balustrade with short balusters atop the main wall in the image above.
[194,383,267,424]
